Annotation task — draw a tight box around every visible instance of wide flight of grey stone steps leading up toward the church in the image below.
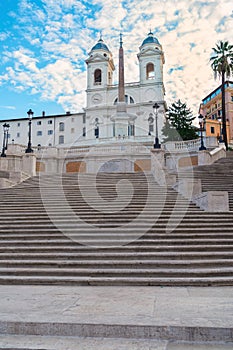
[0,167,233,286]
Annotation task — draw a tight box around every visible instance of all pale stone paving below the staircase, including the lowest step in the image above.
[0,286,233,350]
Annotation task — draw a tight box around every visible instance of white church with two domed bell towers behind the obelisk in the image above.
[85,32,166,139]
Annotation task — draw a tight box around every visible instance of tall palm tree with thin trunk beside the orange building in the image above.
[210,41,233,150]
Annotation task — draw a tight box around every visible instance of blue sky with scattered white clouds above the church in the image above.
[0,0,233,119]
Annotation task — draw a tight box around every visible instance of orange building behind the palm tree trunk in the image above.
[199,81,233,143]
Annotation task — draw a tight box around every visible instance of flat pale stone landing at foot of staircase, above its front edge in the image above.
[0,286,233,327]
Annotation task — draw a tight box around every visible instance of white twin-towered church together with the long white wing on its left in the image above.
[0,32,166,147]
